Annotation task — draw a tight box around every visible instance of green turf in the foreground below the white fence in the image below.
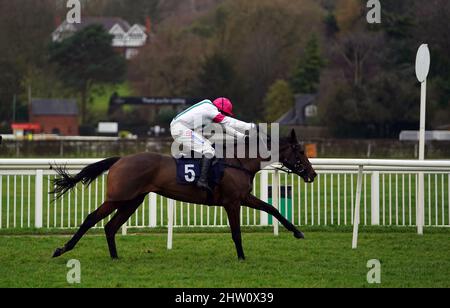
[0,229,450,288]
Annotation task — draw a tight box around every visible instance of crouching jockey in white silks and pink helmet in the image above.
[170,97,254,192]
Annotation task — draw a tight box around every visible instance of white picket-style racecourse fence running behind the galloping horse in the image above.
[0,159,450,230]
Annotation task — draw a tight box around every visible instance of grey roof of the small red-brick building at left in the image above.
[31,99,78,116]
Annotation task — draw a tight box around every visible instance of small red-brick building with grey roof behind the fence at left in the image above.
[30,99,79,136]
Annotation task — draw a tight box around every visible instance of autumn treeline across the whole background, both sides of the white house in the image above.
[0,0,450,137]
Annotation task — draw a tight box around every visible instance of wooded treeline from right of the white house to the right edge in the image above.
[130,0,450,138]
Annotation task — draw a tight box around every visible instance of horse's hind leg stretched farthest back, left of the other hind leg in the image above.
[53,202,118,258]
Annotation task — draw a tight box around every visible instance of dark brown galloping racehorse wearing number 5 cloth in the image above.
[53,130,317,260]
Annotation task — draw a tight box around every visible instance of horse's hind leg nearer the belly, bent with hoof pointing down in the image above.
[105,195,145,259]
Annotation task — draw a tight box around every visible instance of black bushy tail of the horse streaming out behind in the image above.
[50,157,121,199]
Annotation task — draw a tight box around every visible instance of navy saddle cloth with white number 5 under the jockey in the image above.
[175,158,225,189]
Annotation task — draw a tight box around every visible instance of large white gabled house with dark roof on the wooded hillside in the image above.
[52,17,151,60]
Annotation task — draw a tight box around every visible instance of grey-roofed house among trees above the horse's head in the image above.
[277,94,318,126]
